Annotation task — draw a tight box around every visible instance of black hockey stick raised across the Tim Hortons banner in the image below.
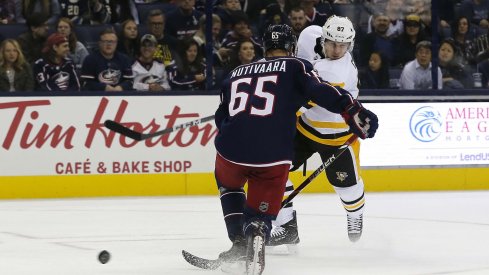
[104,115,214,141]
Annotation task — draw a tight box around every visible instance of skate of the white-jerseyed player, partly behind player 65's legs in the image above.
[267,210,300,254]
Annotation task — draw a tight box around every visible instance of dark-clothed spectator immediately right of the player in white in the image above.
[360,52,390,89]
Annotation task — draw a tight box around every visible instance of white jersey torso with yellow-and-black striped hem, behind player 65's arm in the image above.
[297,52,358,146]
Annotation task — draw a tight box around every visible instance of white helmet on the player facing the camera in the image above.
[321,15,355,51]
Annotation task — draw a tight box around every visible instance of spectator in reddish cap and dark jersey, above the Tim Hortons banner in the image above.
[34,33,80,91]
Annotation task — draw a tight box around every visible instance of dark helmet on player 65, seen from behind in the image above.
[263,24,297,55]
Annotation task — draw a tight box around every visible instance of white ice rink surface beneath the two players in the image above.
[0,191,489,275]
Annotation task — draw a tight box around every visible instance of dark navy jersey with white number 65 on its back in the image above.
[215,57,353,166]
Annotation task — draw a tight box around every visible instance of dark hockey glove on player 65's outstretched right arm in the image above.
[341,100,379,139]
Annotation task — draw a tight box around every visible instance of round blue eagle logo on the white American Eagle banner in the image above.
[409,106,442,142]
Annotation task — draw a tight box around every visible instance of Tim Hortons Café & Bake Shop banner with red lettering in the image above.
[0,96,219,176]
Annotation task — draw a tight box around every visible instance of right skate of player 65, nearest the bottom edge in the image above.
[246,221,266,275]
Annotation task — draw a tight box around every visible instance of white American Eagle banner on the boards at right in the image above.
[360,102,489,166]
